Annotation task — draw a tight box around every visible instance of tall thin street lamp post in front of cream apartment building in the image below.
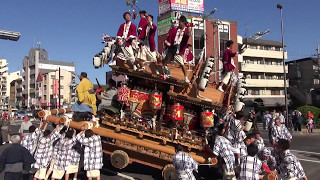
[277,4,289,127]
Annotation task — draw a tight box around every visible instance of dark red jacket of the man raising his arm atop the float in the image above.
[166,27,189,55]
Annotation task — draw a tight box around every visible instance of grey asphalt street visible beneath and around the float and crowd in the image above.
[0,121,320,180]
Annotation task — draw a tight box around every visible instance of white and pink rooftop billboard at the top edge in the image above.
[159,0,204,15]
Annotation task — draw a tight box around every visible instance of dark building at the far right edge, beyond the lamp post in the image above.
[286,57,320,107]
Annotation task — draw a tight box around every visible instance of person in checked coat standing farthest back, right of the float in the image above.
[271,118,292,145]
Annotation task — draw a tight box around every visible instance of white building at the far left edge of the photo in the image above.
[0,59,21,109]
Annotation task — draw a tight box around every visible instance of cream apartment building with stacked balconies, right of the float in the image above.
[238,37,289,107]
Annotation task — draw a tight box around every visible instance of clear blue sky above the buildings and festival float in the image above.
[0,0,320,84]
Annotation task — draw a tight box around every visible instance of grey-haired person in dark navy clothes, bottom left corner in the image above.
[0,135,35,180]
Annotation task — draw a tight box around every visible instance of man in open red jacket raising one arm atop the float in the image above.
[163,16,192,83]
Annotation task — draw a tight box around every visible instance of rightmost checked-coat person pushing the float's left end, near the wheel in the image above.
[77,129,103,180]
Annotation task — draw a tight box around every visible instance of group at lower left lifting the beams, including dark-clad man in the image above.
[0,121,103,180]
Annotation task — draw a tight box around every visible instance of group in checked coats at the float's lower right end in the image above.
[173,108,307,180]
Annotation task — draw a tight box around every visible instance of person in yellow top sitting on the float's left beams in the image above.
[71,72,97,115]
